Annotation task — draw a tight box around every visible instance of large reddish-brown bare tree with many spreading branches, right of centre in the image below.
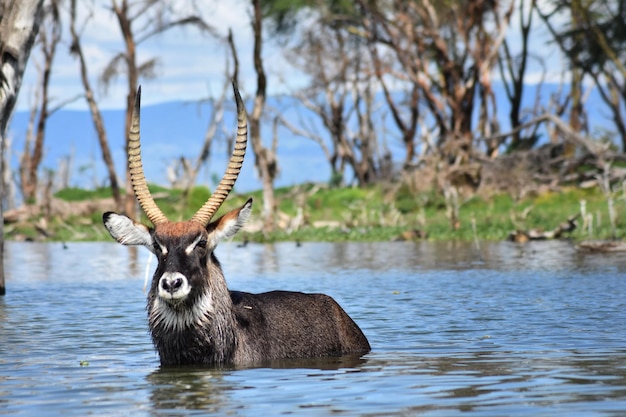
[358,0,514,164]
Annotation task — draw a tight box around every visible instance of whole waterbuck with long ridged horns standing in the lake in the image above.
[103,85,370,366]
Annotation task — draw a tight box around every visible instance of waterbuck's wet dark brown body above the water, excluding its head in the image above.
[148,291,370,365]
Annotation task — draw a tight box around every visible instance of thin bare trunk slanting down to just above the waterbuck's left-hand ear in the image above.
[70,0,124,211]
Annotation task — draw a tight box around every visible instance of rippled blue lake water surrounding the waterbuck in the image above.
[0,242,626,416]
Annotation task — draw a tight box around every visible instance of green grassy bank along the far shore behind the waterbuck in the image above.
[5,184,626,241]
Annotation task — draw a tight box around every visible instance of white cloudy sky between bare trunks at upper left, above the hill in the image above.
[17,0,260,110]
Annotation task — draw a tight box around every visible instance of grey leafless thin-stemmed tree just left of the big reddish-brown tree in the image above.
[281,20,386,185]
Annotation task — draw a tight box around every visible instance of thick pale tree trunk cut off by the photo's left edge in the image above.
[0,0,43,295]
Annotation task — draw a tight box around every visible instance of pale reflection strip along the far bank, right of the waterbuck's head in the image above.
[217,237,626,278]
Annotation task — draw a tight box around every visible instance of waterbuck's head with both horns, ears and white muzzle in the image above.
[102,84,252,307]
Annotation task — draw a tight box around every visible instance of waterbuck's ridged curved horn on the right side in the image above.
[191,81,248,226]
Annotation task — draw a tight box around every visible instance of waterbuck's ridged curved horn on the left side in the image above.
[128,86,169,226]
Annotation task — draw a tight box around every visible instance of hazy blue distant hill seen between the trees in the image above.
[9,84,611,197]
